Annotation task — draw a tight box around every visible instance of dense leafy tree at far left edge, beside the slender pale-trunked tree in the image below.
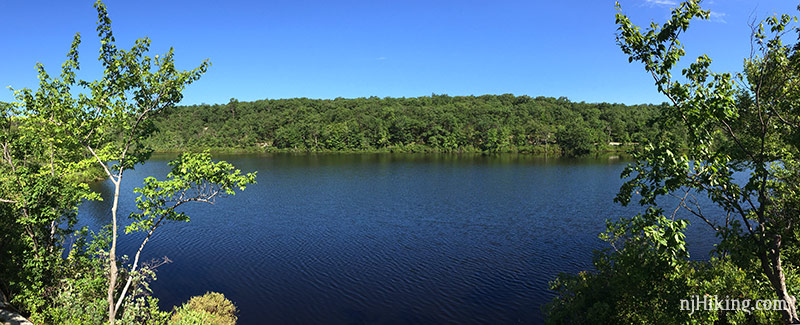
[0,93,98,312]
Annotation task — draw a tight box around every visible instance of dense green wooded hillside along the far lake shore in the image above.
[148,94,682,155]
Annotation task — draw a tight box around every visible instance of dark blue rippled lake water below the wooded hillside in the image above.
[80,154,713,324]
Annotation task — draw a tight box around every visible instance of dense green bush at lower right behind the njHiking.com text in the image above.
[544,210,800,324]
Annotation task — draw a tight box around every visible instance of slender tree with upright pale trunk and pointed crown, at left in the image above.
[65,2,208,324]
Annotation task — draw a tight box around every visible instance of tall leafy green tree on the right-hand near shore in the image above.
[551,1,800,324]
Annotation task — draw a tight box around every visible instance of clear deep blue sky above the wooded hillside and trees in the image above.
[0,0,797,104]
